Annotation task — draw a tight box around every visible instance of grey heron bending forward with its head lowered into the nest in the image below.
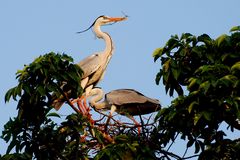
[89,88,161,131]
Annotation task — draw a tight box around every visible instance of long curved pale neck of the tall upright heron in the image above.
[94,26,114,56]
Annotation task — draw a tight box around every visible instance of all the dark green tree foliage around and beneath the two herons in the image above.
[0,26,240,160]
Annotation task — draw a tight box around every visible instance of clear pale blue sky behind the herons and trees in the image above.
[0,0,240,158]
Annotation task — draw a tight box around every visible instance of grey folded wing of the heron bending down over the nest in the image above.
[106,89,159,105]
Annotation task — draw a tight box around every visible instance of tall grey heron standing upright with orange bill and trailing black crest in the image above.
[52,16,127,110]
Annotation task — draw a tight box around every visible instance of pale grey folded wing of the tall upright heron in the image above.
[78,54,101,78]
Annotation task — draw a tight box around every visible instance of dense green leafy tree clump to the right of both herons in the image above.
[153,27,240,159]
